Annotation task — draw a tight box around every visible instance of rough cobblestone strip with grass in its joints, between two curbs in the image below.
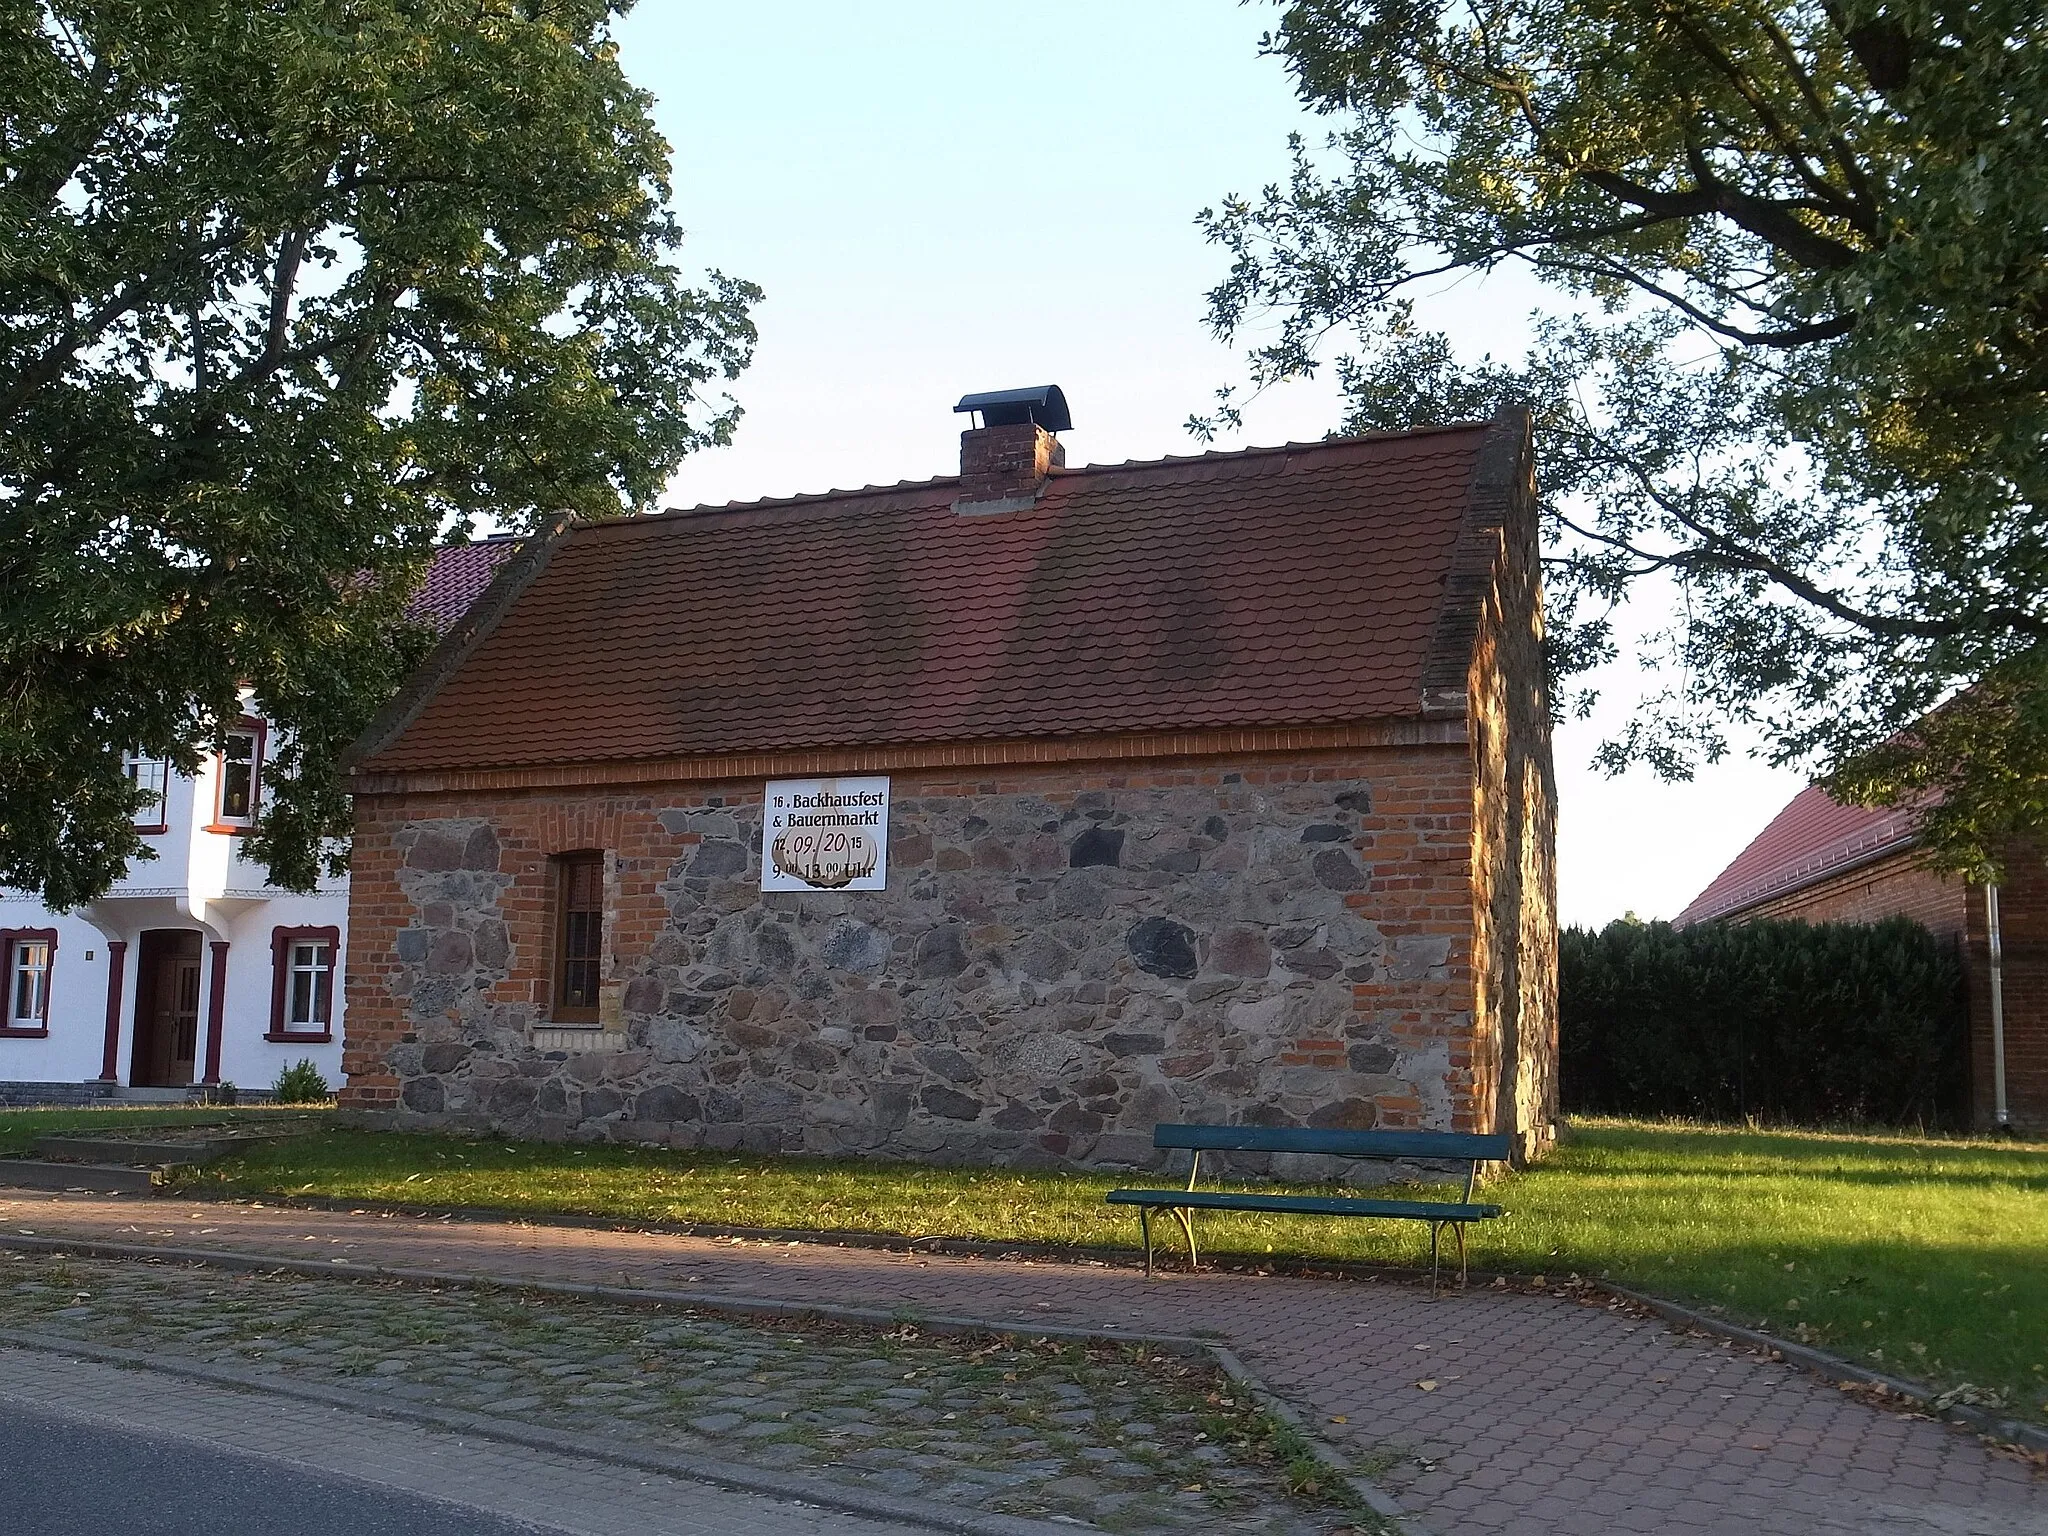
[0,1253,1376,1536]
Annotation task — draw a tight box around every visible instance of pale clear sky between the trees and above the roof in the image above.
[618,0,1802,922]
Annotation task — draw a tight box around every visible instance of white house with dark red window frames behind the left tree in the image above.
[0,539,514,1104]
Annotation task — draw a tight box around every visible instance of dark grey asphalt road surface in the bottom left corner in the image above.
[0,1401,543,1536]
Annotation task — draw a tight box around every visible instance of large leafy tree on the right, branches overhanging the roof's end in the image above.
[1198,0,2048,868]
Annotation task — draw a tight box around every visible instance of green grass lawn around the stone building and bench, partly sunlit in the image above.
[0,1112,2048,1419]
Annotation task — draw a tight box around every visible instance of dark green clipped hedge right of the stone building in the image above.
[1559,918,1966,1124]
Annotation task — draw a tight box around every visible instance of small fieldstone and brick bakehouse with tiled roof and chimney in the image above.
[342,391,1556,1165]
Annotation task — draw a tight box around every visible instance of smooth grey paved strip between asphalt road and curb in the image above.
[0,1348,937,1536]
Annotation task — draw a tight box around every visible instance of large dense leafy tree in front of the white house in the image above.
[0,0,758,905]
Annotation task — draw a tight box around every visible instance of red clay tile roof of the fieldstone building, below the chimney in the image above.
[360,426,1487,772]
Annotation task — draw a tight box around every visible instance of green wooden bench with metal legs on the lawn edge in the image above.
[1108,1124,1511,1296]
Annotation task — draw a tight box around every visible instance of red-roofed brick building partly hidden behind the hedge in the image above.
[1677,784,2048,1133]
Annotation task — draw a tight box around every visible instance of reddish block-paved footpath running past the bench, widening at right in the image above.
[0,1194,2048,1536]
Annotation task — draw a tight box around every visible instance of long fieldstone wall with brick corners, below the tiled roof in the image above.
[346,743,1493,1171]
